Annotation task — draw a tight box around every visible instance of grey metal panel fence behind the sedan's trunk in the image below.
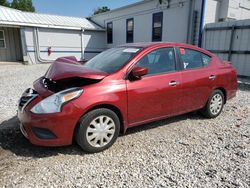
[202,20,250,76]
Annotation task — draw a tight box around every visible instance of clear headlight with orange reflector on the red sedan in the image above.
[30,88,83,114]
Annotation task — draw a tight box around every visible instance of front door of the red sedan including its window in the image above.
[126,48,181,126]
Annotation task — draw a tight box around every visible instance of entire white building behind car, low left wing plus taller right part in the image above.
[0,0,250,63]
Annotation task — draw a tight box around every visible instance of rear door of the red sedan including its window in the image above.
[179,47,216,112]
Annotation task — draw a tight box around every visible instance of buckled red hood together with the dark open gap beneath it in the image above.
[33,57,108,97]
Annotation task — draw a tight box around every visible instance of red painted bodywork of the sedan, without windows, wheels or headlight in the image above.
[18,43,237,146]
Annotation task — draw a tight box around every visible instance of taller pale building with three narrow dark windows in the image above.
[91,0,250,48]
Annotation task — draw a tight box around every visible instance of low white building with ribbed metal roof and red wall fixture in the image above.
[0,6,105,64]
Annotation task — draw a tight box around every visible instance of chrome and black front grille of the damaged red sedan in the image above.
[18,88,38,112]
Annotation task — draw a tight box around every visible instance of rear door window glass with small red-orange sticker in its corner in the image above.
[180,48,211,70]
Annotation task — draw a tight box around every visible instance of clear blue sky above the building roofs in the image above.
[33,0,140,17]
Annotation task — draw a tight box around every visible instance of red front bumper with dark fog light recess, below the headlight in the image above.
[18,99,82,146]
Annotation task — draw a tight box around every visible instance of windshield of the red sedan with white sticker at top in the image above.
[83,47,140,73]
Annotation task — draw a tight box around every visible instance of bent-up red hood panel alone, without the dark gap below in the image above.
[45,57,108,81]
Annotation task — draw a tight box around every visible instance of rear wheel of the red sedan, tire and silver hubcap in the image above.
[201,89,225,118]
